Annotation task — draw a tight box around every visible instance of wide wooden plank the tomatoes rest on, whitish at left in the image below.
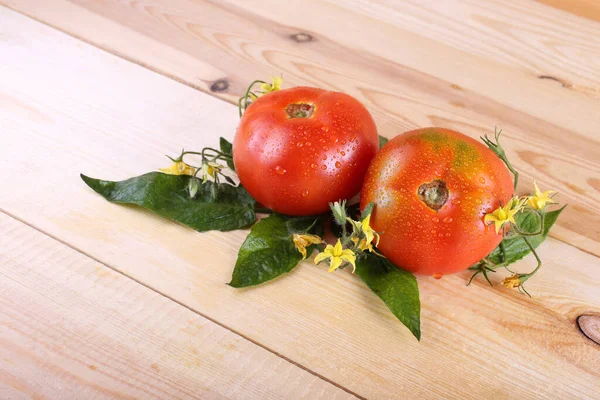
[0,11,600,399]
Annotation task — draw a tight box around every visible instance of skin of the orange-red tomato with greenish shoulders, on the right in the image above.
[360,128,513,276]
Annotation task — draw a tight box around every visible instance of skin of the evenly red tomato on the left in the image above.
[233,87,379,216]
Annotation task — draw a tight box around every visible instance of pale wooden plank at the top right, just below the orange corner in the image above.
[324,0,600,97]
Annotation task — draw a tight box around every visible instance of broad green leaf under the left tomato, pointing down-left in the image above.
[229,214,317,288]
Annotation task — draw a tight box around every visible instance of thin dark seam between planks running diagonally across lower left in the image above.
[0,208,366,400]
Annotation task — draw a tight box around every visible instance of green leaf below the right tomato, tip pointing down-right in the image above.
[356,254,421,340]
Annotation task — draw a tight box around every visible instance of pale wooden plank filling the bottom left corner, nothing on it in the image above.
[0,213,355,399]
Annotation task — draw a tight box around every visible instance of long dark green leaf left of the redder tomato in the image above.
[81,172,256,232]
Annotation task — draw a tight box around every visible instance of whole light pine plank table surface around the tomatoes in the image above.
[0,0,600,399]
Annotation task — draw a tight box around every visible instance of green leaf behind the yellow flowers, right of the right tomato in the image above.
[488,206,566,266]
